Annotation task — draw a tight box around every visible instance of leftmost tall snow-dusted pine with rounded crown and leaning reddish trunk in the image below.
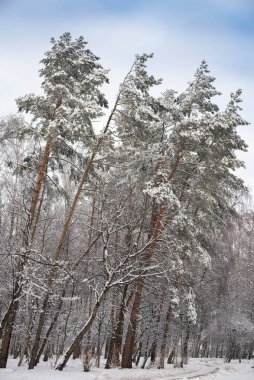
[0,33,108,368]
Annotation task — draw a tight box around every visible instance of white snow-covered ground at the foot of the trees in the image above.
[0,359,254,380]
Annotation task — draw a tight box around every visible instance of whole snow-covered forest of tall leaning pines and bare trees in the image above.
[0,33,254,372]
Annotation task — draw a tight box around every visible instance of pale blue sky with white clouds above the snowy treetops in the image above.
[0,0,254,194]
